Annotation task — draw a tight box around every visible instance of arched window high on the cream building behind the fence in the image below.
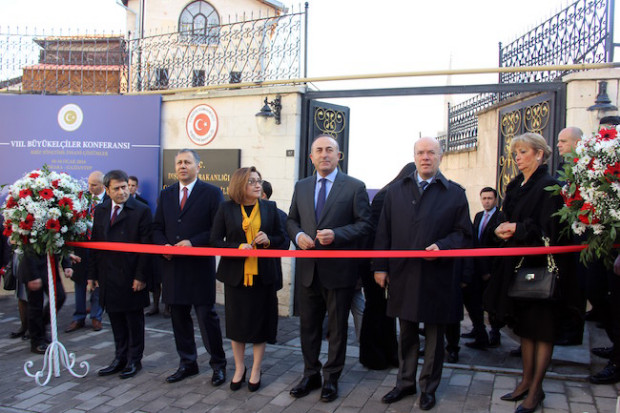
[179,0,220,44]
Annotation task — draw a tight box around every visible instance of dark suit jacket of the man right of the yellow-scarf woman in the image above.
[286,172,371,289]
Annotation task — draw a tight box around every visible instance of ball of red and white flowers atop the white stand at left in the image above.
[2,165,92,255]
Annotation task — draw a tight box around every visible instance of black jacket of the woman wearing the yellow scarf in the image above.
[211,199,284,287]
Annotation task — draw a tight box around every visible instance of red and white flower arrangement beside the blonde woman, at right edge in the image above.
[553,129,620,267]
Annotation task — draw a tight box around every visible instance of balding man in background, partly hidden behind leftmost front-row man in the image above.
[65,171,108,333]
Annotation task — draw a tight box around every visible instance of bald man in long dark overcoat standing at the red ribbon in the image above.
[374,138,471,410]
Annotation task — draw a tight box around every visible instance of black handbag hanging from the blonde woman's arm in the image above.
[508,238,559,301]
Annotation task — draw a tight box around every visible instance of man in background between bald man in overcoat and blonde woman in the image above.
[461,186,504,350]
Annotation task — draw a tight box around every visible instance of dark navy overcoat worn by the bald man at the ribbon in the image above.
[374,173,471,324]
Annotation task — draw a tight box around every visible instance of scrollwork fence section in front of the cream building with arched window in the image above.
[129,13,304,91]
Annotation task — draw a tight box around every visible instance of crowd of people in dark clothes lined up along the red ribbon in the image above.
[2,128,620,413]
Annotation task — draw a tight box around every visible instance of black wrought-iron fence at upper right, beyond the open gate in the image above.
[446,0,614,151]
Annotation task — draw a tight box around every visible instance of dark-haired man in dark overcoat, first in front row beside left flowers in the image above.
[88,170,151,379]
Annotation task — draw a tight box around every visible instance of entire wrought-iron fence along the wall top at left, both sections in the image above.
[0,12,305,93]
